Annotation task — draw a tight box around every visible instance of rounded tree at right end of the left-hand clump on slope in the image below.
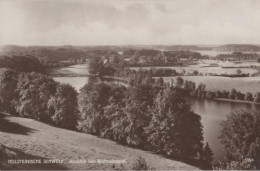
[48,84,78,129]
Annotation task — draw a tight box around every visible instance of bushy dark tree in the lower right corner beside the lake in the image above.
[219,110,260,168]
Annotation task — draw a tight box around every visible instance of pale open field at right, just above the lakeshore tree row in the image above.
[164,76,260,93]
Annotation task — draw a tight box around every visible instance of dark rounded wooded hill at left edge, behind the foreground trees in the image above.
[0,55,44,72]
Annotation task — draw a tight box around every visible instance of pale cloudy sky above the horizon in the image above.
[0,0,260,46]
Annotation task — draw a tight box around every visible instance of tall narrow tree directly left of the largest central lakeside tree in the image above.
[124,84,154,146]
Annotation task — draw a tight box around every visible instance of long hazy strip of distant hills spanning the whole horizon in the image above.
[0,44,260,62]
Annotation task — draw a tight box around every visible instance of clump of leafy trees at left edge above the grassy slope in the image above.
[0,69,79,129]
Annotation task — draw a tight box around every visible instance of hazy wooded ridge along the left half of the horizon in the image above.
[0,45,118,61]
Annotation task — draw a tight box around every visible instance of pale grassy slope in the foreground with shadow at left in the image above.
[0,113,196,170]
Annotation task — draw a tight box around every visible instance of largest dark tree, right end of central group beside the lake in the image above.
[146,88,203,160]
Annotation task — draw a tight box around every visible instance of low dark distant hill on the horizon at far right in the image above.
[214,44,260,52]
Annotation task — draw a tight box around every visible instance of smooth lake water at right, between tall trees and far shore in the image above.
[188,98,260,162]
